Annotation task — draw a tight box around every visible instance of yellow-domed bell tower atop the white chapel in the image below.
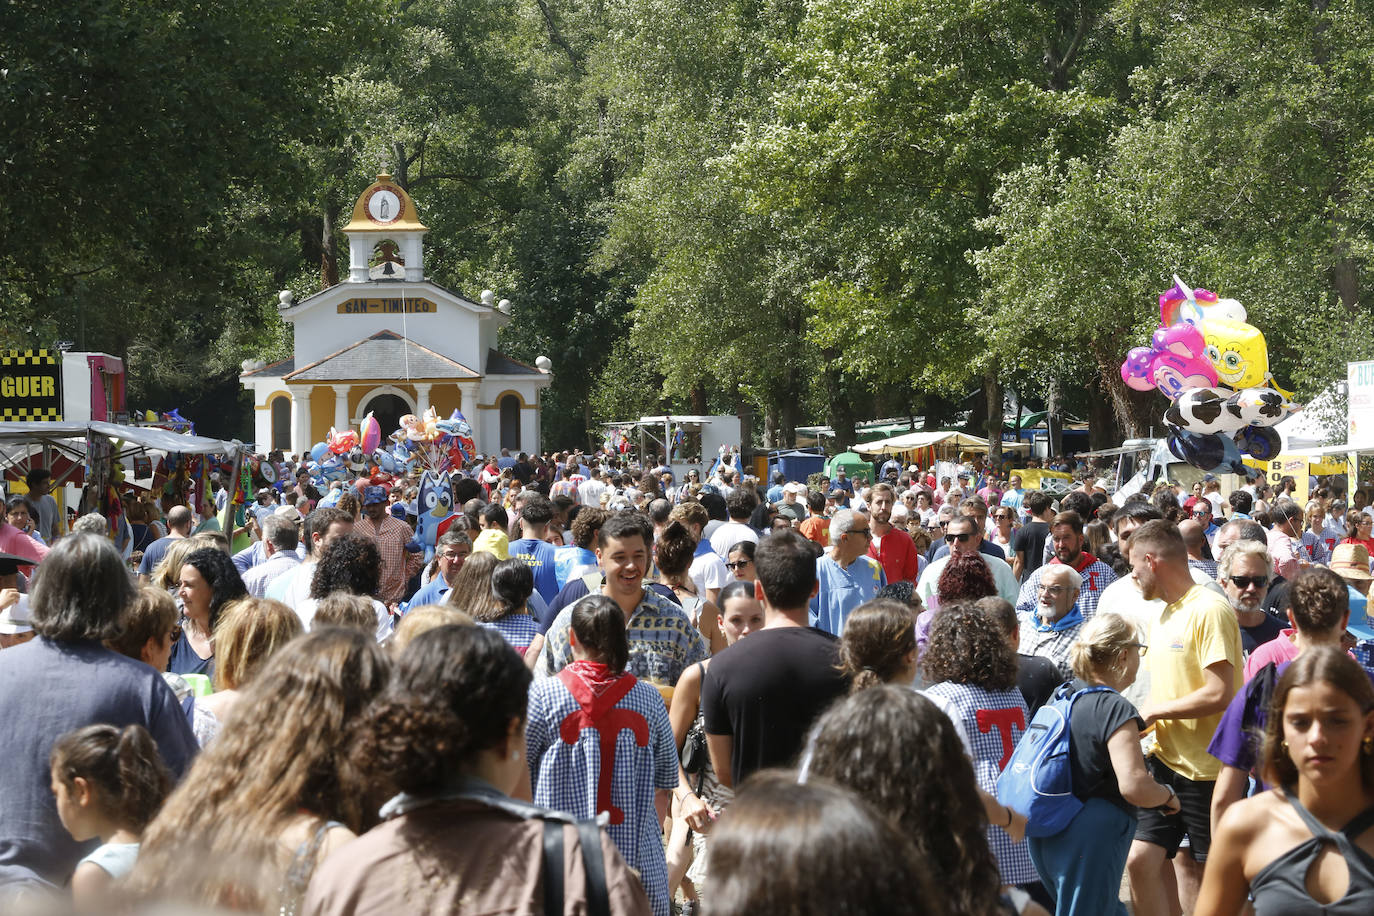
[344,172,429,283]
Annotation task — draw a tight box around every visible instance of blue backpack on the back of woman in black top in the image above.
[998,684,1110,836]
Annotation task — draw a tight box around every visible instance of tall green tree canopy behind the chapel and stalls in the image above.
[0,0,1374,446]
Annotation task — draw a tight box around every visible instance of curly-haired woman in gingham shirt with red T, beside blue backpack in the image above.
[921,603,1038,906]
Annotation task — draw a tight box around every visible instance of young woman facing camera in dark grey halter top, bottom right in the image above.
[1194,645,1374,916]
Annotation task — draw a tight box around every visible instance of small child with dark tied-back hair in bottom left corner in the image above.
[49,725,172,911]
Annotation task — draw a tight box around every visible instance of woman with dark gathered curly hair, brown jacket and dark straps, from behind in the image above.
[302,626,645,916]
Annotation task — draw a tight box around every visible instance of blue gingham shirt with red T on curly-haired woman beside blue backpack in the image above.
[925,681,1040,884]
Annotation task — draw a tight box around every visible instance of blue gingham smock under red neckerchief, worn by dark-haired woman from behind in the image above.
[525,677,677,916]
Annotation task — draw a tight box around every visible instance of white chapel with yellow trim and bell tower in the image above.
[239,173,554,455]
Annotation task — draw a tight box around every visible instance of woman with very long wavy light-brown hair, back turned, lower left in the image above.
[129,626,390,916]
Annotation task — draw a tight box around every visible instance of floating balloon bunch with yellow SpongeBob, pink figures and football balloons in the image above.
[1121,276,1300,475]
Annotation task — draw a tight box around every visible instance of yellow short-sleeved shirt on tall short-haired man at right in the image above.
[1149,585,1243,781]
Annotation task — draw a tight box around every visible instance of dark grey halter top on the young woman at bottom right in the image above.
[1250,792,1374,916]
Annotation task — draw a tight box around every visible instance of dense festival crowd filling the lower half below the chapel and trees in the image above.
[0,442,1374,916]
